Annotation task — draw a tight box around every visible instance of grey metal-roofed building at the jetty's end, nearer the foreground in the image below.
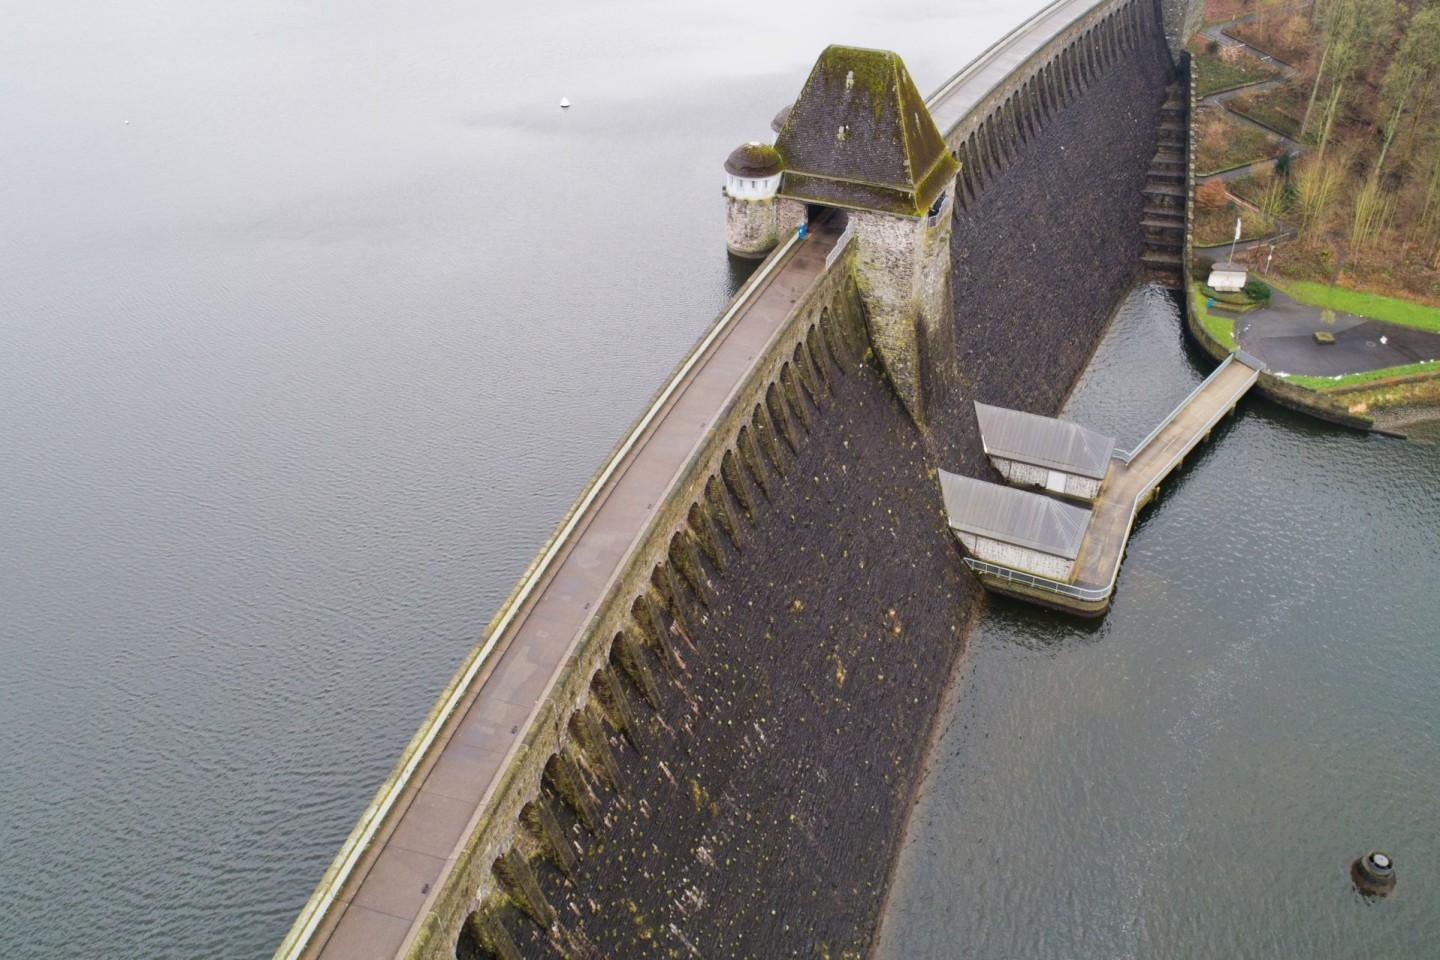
[940,471,1090,581]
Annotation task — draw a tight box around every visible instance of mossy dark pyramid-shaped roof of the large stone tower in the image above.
[775,46,960,216]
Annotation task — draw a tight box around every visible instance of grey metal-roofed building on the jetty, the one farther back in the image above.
[975,402,1115,501]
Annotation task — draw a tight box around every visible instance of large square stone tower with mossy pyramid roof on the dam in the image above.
[775,46,959,423]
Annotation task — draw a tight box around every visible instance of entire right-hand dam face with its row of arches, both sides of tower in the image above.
[275,3,1198,957]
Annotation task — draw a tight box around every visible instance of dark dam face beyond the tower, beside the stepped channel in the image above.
[930,16,1175,479]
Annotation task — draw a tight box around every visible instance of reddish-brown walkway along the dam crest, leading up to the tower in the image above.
[289,219,842,960]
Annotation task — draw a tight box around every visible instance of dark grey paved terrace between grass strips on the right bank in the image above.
[1232,291,1440,377]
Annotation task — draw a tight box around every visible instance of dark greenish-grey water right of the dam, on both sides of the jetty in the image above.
[878,288,1440,960]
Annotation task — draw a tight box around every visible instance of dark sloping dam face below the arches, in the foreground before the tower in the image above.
[472,306,975,957]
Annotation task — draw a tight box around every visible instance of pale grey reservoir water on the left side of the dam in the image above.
[0,0,1041,960]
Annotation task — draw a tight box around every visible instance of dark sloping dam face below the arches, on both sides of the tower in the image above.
[472,13,1172,960]
